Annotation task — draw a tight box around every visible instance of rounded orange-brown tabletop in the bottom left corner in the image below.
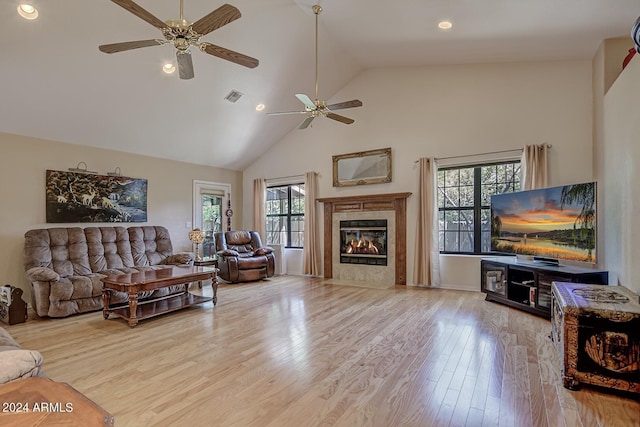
[0,377,114,427]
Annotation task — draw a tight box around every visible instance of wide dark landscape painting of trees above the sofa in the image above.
[46,170,147,223]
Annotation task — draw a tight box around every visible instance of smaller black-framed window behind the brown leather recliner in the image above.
[266,184,304,248]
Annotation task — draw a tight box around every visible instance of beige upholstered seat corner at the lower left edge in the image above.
[0,328,44,384]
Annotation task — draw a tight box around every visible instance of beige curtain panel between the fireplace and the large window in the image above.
[413,157,440,286]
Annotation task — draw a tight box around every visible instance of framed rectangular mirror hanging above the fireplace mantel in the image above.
[333,148,391,187]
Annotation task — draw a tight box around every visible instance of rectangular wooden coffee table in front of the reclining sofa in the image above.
[102,266,218,327]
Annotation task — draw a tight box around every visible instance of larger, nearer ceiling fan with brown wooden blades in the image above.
[98,0,258,80]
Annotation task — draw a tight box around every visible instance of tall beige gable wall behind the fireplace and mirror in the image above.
[243,61,593,290]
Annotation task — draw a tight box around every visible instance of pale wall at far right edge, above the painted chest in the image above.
[602,55,640,294]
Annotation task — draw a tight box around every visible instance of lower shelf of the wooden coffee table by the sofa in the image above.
[104,292,215,326]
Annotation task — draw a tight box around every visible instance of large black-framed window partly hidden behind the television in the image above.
[438,161,520,254]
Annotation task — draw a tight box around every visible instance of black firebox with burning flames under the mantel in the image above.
[340,219,387,265]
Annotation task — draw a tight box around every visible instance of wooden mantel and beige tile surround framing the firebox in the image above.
[318,193,411,285]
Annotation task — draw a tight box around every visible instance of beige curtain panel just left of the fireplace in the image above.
[302,172,320,276]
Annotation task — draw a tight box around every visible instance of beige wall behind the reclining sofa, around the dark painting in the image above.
[0,133,242,302]
